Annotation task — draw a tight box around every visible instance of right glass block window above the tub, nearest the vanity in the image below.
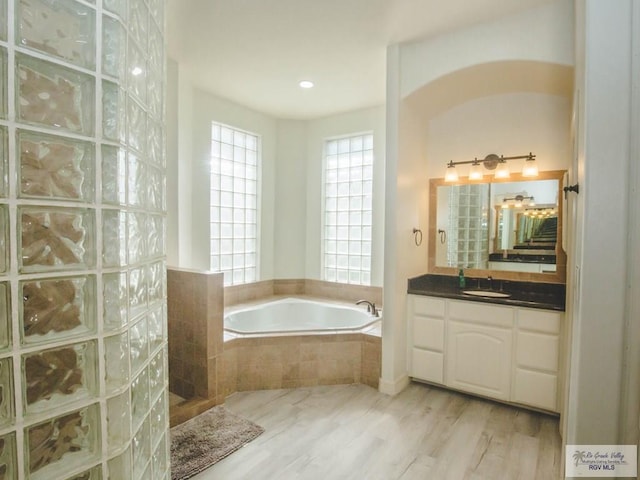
[322,133,373,285]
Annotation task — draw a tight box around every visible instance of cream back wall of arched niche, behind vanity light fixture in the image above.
[425,92,571,178]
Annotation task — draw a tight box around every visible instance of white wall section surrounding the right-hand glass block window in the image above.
[304,107,385,286]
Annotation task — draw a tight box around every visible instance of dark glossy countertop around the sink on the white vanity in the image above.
[407,274,566,312]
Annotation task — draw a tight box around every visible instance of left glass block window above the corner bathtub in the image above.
[210,123,260,285]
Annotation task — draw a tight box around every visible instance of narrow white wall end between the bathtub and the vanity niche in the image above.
[380,59,429,394]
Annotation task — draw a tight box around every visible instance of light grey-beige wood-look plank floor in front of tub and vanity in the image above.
[193,383,561,480]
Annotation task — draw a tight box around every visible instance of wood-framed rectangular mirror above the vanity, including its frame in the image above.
[429,170,566,283]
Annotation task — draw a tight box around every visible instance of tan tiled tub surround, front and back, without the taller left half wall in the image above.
[218,292,382,397]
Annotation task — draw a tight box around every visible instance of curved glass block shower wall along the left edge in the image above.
[0,0,170,480]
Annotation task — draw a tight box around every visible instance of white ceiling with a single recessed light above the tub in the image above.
[167,0,554,119]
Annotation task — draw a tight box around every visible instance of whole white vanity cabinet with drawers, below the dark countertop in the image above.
[407,295,563,412]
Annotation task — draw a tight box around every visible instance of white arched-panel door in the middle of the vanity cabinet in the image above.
[445,321,512,400]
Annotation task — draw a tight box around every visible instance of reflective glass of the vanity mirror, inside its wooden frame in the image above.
[434,179,560,273]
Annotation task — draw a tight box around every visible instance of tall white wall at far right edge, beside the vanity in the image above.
[565,0,640,445]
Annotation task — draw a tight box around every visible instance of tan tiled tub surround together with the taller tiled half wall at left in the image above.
[167,267,382,426]
